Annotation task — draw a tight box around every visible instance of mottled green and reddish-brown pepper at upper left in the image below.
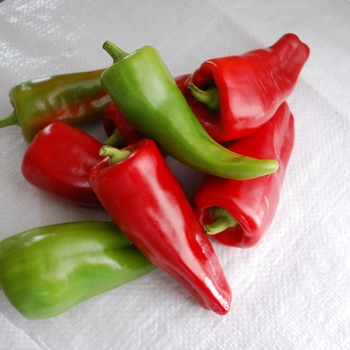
[0,69,110,143]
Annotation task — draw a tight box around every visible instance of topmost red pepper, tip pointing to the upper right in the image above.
[182,34,310,142]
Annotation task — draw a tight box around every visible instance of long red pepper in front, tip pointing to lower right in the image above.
[89,139,231,314]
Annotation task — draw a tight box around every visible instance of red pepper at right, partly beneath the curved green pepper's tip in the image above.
[193,103,294,248]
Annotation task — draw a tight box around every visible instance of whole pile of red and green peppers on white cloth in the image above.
[0,34,309,319]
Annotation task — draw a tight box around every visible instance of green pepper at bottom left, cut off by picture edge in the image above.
[0,221,155,320]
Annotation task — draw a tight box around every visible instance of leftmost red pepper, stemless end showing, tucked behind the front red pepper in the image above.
[22,122,103,208]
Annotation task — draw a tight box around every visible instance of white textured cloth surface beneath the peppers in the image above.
[0,0,350,350]
